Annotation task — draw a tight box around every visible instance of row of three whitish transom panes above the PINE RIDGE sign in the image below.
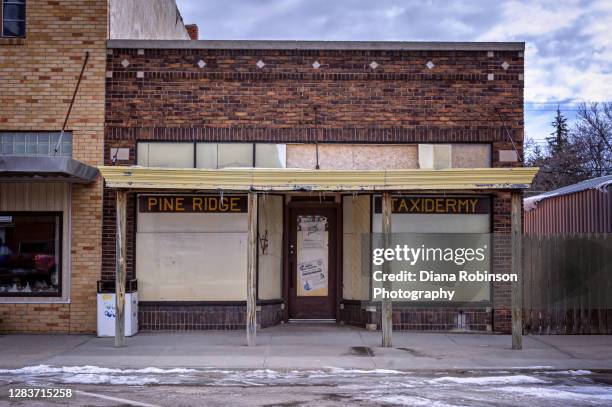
[136,142,287,169]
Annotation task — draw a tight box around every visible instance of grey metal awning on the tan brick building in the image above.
[0,156,98,183]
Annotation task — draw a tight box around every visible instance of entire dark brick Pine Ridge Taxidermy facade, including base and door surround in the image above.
[102,41,524,332]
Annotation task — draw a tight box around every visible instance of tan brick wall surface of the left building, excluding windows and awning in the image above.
[0,0,107,332]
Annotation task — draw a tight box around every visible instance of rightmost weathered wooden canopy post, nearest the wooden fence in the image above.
[510,190,523,349]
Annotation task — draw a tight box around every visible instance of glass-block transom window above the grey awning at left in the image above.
[0,132,72,157]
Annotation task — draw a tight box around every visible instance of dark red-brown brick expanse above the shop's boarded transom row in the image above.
[107,49,523,131]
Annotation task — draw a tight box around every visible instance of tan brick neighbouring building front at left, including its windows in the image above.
[0,0,188,333]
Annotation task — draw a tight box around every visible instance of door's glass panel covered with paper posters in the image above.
[296,215,329,297]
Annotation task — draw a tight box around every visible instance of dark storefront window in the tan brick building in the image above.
[0,212,62,297]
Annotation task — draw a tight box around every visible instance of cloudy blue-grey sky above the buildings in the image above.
[177,0,612,144]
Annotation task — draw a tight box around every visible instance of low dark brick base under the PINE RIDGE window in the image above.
[138,302,283,331]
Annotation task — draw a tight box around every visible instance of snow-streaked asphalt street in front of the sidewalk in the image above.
[0,368,612,407]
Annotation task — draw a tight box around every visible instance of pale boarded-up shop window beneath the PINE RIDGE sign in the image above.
[136,196,247,301]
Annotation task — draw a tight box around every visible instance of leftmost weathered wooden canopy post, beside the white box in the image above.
[115,189,127,348]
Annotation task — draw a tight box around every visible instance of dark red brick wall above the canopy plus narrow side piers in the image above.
[103,43,524,331]
